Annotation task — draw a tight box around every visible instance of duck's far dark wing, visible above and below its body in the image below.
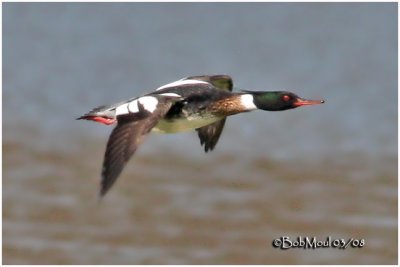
[186,75,233,152]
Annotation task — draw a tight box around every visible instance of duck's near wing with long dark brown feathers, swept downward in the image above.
[100,99,173,196]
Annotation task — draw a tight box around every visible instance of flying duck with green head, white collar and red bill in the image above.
[77,75,325,197]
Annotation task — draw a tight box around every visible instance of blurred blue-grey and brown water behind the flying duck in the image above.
[2,3,398,264]
